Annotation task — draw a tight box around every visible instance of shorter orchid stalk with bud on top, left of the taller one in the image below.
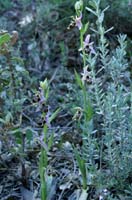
[37,79,60,200]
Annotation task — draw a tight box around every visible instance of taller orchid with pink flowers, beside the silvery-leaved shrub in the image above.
[70,0,96,197]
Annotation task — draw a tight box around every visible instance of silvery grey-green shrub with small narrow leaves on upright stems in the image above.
[75,0,132,199]
